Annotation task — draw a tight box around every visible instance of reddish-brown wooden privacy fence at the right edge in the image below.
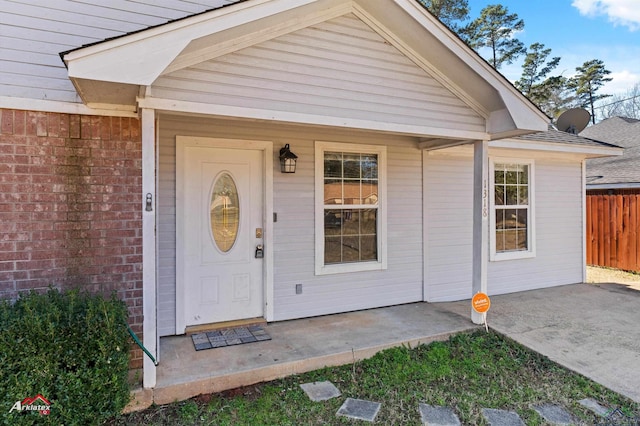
[587,194,640,271]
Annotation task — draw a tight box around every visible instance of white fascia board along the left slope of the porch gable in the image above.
[64,0,317,86]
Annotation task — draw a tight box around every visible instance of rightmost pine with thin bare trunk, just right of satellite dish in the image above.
[568,59,613,124]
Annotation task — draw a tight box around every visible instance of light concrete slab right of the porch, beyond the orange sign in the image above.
[437,284,640,402]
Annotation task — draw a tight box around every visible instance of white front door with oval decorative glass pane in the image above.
[177,146,264,326]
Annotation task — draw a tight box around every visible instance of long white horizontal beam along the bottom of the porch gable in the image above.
[137,97,487,140]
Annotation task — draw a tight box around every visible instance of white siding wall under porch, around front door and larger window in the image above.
[158,115,423,336]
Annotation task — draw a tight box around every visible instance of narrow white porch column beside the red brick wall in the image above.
[141,108,158,388]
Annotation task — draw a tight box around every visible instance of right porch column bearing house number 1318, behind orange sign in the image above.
[471,141,490,324]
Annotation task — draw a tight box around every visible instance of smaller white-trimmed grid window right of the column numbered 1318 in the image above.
[490,158,535,260]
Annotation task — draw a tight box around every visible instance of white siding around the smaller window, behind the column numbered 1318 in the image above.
[424,149,583,302]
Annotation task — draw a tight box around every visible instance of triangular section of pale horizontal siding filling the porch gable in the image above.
[150,15,485,132]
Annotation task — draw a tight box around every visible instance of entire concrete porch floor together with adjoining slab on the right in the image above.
[129,278,640,410]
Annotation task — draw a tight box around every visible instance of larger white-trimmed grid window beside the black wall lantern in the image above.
[315,142,386,275]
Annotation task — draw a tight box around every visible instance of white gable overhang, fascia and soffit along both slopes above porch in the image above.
[63,0,548,139]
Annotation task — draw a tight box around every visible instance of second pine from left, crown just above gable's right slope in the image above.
[461,4,526,69]
